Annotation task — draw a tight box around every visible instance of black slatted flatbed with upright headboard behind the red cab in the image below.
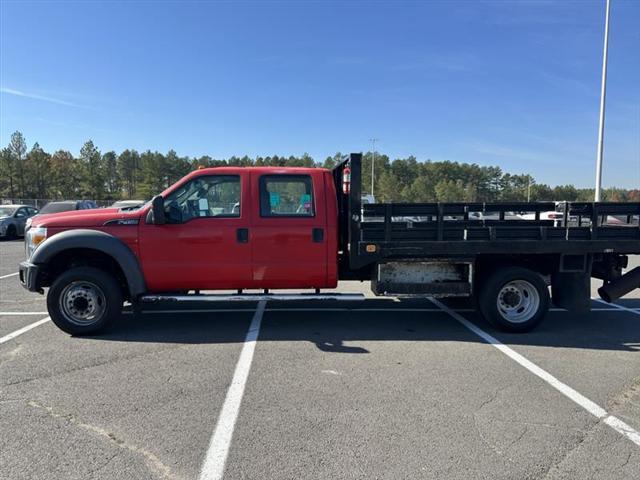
[334,154,640,269]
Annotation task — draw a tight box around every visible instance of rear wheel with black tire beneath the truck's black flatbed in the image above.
[477,267,550,333]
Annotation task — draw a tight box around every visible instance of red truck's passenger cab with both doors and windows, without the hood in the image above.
[138,167,338,292]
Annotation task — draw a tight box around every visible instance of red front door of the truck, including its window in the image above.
[140,172,252,291]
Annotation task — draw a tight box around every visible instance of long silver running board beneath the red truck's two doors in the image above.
[140,293,364,303]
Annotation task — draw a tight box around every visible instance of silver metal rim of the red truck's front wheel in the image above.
[60,281,107,326]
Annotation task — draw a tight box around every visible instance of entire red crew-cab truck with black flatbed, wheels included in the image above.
[20,154,640,334]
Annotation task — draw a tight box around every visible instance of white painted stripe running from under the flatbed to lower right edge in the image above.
[431,299,640,446]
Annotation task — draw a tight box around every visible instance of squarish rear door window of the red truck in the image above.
[260,175,315,217]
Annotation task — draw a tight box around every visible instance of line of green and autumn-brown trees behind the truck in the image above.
[0,132,640,202]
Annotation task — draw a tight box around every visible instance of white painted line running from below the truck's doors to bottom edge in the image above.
[200,300,266,480]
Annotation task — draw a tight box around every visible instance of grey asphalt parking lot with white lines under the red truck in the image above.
[0,241,640,480]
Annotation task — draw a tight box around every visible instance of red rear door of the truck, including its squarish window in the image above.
[250,171,328,288]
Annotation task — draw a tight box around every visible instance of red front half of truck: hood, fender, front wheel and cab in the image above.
[20,167,338,334]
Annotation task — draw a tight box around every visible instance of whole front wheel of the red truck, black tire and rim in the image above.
[47,267,123,335]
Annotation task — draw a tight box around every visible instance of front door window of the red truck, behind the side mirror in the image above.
[164,175,240,223]
